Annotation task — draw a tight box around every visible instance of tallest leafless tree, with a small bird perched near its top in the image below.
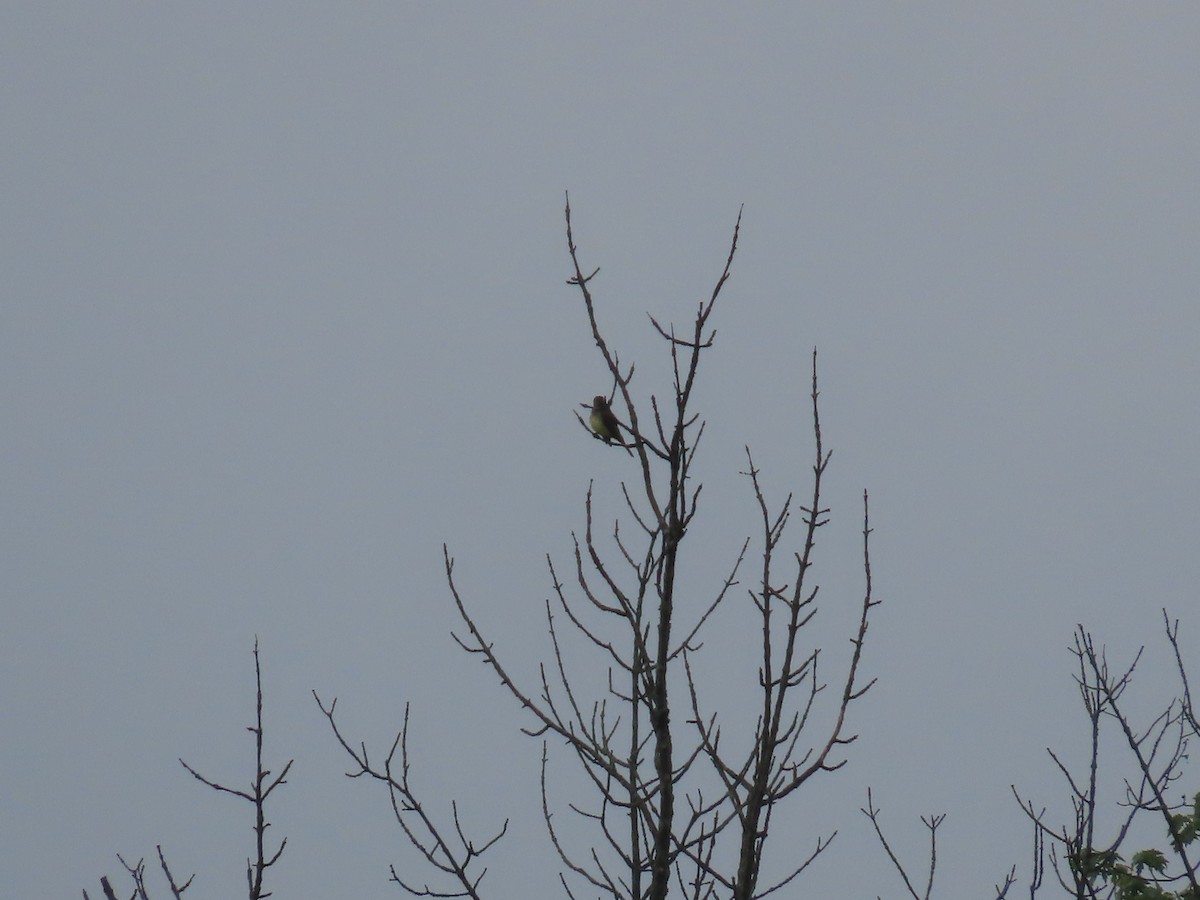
[318,202,878,900]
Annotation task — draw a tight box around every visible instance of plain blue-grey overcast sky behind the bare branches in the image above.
[0,2,1200,898]
